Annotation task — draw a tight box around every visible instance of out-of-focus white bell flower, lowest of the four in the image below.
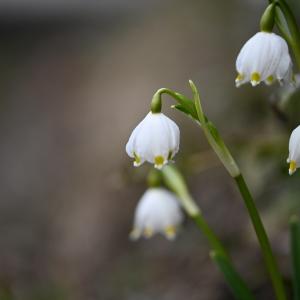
[130,188,183,240]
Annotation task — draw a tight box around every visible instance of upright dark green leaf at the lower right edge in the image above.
[290,216,300,300]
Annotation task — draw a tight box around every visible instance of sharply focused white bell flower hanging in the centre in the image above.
[126,112,180,169]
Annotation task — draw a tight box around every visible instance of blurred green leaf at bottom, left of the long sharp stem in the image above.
[210,251,254,300]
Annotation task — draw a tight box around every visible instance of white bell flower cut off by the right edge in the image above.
[287,125,300,175]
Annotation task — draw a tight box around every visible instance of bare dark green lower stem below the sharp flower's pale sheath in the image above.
[234,174,287,300]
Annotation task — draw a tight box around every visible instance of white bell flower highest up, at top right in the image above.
[235,32,293,87]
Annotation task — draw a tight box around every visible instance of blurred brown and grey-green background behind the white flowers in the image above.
[0,0,300,300]
